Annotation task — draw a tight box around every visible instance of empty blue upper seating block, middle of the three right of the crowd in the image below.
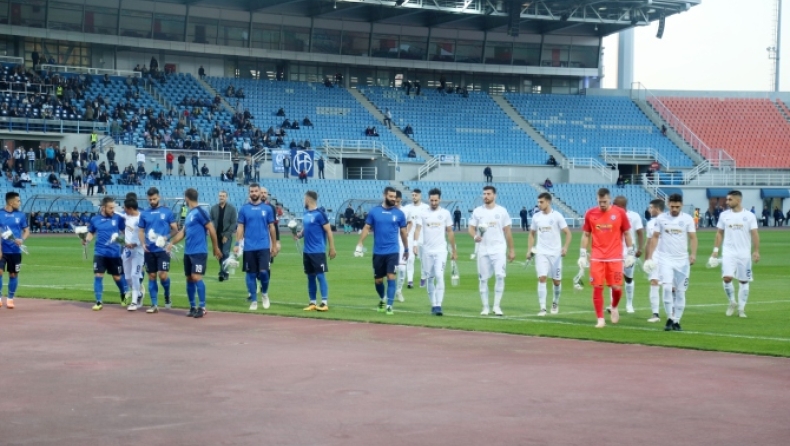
[360,87,549,165]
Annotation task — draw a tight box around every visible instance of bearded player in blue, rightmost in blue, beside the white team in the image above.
[354,186,409,315]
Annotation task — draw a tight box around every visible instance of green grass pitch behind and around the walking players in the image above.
[12,230,790,356]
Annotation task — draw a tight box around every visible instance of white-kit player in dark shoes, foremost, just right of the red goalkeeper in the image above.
[645,194,697,331]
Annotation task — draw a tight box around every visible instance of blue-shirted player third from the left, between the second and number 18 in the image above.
[138,187,178,313]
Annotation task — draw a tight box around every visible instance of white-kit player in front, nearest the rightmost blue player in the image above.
[413,189,458,316]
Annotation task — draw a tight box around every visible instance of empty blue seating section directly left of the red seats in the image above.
[505,93,694,168]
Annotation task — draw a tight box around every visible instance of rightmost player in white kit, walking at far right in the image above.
[708,190,760,317]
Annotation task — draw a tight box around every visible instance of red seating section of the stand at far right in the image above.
[659,97,790,168]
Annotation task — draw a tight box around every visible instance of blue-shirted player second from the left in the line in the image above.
[82,196,127,311]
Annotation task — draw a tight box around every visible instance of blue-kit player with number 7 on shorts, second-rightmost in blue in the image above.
[294,190,337,311]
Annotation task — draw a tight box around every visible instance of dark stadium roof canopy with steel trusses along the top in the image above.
[160,0,702,36]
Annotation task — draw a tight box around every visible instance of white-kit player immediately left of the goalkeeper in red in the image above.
[527,192,571,316]
